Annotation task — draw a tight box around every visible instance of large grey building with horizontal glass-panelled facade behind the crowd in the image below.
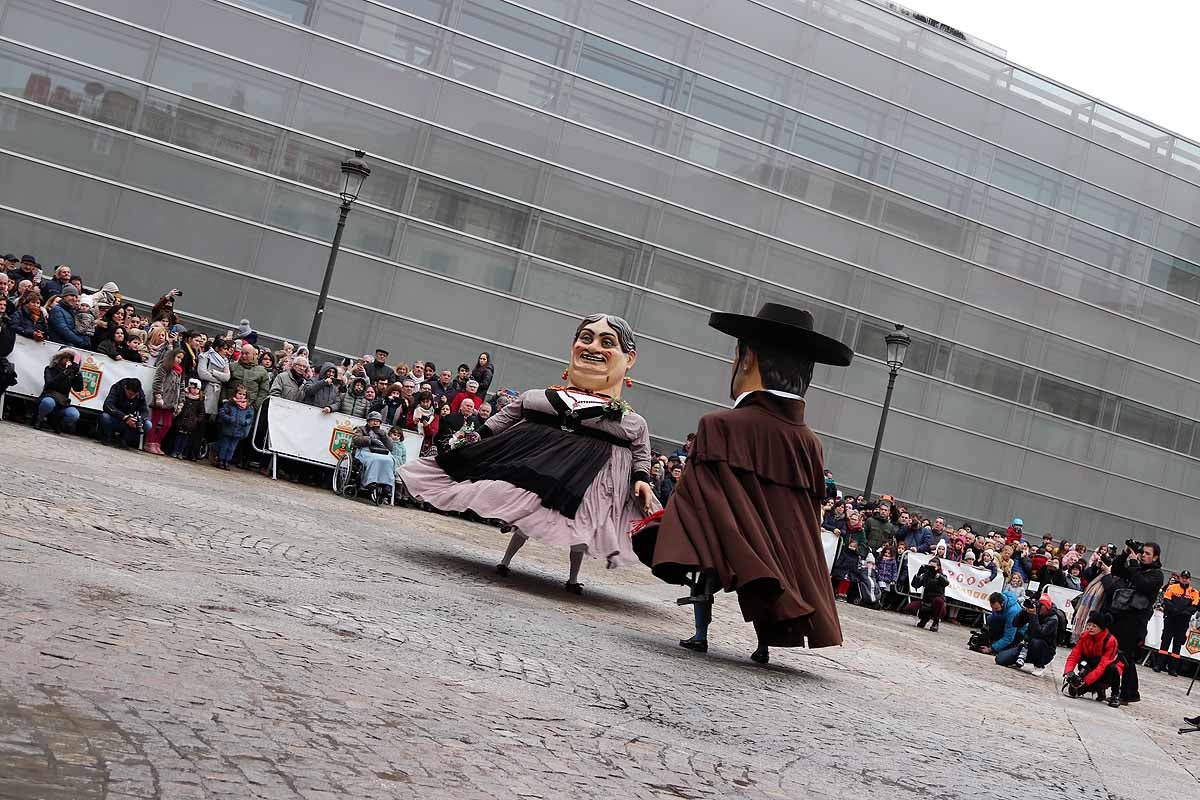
[0,0,1200,565]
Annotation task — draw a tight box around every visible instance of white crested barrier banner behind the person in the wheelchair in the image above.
[266,397,424,467]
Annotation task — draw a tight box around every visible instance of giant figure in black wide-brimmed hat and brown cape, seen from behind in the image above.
[634,303,853,664]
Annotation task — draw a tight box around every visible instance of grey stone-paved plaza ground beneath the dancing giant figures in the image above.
[0,422,1200,800]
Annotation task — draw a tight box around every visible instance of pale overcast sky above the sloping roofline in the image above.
[896,0,1200,142]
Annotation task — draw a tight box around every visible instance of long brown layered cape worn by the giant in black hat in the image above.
[634,392,841,648]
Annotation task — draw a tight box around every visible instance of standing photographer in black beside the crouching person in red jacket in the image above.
[1105,539,1163,703]
